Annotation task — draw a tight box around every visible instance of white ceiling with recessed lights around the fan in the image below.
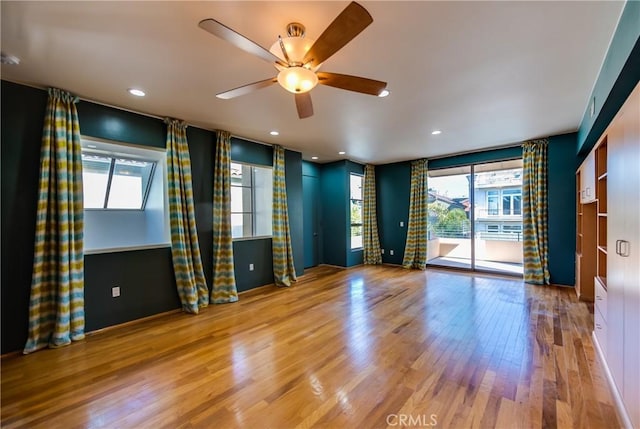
[0,1,624,163]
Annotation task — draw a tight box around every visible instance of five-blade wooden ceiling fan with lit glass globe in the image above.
[198,2,387,119]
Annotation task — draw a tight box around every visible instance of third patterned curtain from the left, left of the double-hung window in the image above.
[211,131,238,304]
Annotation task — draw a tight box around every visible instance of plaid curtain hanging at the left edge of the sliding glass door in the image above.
[402,159,428,270]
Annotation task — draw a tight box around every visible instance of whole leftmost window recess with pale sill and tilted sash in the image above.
[82,137,171,254]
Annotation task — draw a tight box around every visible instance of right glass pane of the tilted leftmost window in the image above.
[107,159,153,209]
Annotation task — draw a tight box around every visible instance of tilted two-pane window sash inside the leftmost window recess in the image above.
[82,150,156,210]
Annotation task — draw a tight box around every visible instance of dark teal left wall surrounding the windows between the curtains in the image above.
[0,81,304,353]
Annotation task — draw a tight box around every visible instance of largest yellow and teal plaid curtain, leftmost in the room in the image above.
[24,88,84,354]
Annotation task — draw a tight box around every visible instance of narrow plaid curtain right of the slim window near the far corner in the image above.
[363,165,382,265]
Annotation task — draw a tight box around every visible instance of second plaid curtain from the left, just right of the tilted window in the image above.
[165,118,209,314]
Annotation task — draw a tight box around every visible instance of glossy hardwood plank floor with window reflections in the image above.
[1,266,619,428]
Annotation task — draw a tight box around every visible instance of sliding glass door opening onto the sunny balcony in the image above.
[427,159,522,275]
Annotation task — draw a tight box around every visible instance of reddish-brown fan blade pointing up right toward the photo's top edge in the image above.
[303,2,373,68]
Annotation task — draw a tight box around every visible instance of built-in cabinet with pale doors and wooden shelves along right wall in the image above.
[594,84,640,428]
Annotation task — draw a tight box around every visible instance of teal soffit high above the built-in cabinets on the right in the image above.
[577,0,640,154]
